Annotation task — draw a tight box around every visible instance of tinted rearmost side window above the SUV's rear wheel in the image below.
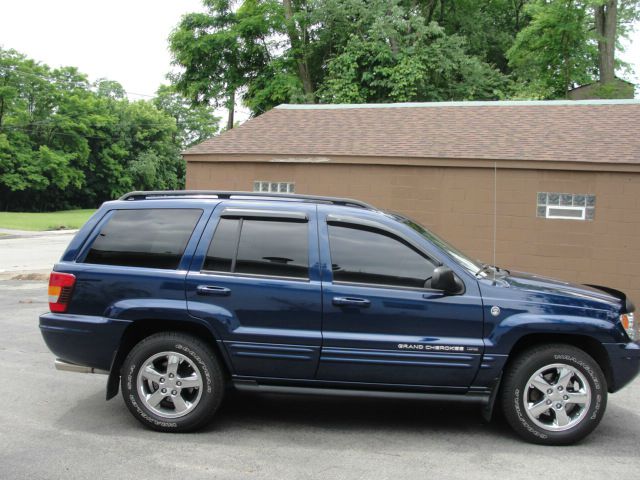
[84,208,202,270]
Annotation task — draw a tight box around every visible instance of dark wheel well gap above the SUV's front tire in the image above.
[505,333,613,389]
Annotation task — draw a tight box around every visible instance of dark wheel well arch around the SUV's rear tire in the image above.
[107,319,231,400]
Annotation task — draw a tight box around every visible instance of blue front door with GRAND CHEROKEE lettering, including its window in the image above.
[317,207,482,389]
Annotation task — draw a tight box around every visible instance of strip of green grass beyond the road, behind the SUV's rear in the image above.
[0,209,95,231]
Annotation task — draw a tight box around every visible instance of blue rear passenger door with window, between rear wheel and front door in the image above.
[186,202,321,379]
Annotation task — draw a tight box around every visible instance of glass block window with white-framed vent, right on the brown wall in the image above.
[536,192,596,220]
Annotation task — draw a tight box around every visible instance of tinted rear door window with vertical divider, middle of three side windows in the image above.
[203,218,309,278]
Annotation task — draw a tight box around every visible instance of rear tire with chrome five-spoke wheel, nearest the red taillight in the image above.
[121,332,225,432]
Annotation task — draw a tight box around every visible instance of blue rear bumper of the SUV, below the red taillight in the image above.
[40,313,131,371]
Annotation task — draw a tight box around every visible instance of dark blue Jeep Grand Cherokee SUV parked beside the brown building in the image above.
[40,191,640,445]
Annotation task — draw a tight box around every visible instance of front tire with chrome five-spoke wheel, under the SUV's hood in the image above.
[501,344,607,445]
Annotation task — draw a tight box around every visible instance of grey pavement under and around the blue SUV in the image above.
[0,234,640,480]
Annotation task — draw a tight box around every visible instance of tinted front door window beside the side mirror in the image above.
[329,225,435,288]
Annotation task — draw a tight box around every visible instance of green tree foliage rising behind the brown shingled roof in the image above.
[170,0,640,114]
